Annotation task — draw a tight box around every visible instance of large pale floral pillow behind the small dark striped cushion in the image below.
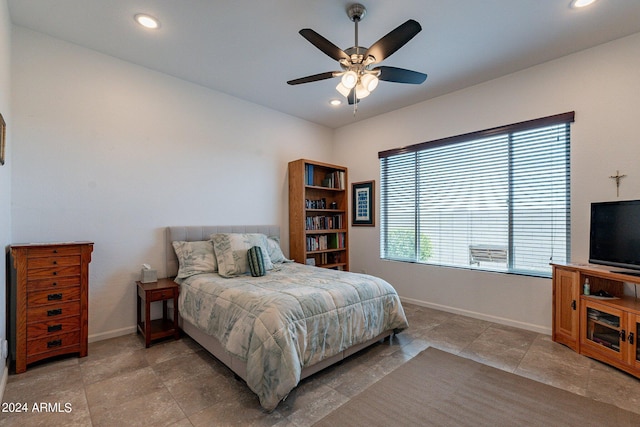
[211,233,273,277]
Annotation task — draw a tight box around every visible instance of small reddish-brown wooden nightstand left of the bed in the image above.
[136,279,180,347]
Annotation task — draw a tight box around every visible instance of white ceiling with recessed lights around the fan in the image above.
[8,0,640,128]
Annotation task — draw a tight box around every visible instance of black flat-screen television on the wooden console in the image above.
[589,200,640,270]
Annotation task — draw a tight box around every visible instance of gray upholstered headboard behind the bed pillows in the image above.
[165,225,280,277]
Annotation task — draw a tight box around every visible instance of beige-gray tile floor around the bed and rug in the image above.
[0,304,640,427]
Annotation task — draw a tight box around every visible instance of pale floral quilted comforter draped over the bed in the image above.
[179,263,408,411]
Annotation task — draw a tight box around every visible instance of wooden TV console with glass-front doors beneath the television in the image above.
[552,264,640,378]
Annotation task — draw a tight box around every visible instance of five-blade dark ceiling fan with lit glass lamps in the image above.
[287,3,427,104]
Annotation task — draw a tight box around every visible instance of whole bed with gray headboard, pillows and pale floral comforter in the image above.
[165,225,408,411]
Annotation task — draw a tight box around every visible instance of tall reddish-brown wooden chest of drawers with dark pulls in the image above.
[7,242,93,373]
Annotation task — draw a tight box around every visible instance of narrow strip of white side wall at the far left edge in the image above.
[0,0,13,400]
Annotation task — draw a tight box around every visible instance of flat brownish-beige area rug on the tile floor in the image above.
[315,348,640,427]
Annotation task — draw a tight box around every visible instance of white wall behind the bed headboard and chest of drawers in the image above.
[11,27,333,340]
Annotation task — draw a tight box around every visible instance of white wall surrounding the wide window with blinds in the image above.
[334,34,640,332]
